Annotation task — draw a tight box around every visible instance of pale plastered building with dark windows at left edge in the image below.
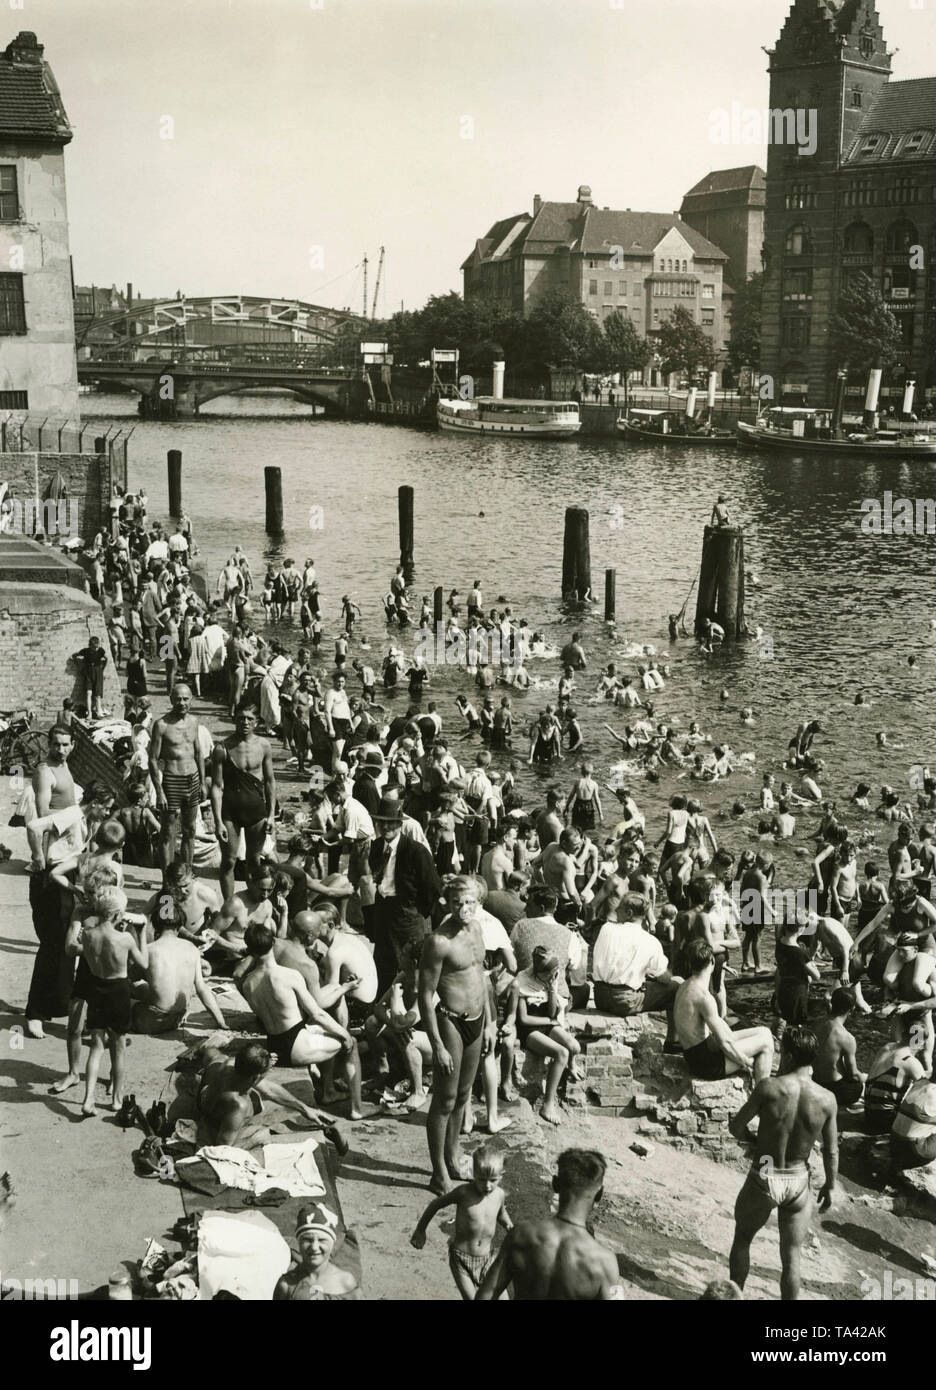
[0,32,78,423]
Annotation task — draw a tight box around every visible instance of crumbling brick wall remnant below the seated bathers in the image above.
[556,1011,748,1163]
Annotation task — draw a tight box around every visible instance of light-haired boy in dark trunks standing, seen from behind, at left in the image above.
[65,888,149,1118]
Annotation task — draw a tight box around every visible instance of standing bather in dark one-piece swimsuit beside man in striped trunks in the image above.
[211,703,277,899]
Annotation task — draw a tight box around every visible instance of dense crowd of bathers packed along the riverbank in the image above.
[12,495,936,1289]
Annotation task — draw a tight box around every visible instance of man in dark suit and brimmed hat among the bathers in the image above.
[370,796,442,992]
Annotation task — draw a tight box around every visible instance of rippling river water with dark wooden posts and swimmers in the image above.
[83,395,936,922]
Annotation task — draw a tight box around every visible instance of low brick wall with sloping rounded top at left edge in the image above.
[0,584,124,727]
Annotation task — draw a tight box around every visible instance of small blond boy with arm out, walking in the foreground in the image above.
[409,1144,513,1302]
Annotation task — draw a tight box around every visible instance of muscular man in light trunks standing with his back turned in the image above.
[729,1024,839,1301]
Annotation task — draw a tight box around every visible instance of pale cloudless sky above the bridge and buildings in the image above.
[18,0,936,316]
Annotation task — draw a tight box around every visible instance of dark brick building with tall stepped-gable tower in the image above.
[761,0,936,404]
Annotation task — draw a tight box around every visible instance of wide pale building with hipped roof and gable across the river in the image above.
[462,183,729,380]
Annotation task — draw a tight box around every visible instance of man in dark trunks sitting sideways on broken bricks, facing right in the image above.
[673,938,773,1083]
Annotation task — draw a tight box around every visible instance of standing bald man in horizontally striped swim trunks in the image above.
[149,684,207,870]
